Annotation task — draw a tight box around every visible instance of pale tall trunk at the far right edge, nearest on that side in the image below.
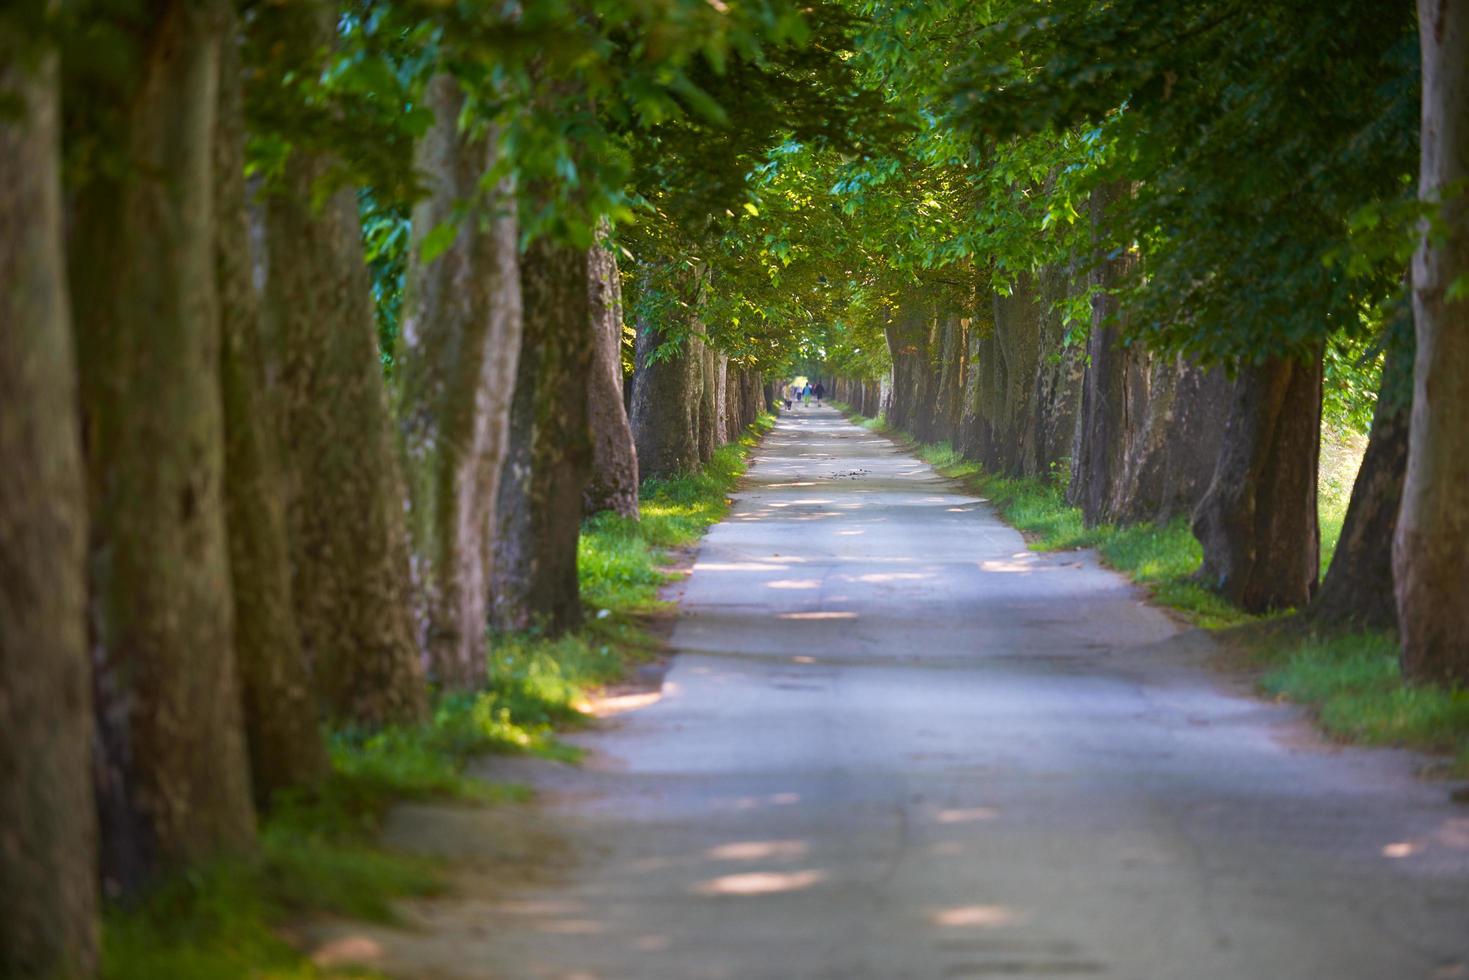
[1393,0,1469,685]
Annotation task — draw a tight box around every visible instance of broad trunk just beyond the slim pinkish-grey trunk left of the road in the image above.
[632,277,699,478]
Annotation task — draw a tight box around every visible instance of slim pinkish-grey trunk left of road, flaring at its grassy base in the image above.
[585,238,638,520]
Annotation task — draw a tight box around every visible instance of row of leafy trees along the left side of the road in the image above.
[0,0,859,977]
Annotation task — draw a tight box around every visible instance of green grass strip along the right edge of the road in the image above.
[852,402,1469,777]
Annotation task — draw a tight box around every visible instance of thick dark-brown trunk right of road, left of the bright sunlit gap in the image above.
[1193,353,1322,613]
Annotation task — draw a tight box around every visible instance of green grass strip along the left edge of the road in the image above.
[100,416,774,980]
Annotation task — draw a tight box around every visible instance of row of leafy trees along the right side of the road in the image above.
[810,3,1469,685]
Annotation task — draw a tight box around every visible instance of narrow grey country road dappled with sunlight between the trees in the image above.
[323,408,1469,980]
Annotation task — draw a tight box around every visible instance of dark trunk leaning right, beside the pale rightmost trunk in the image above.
[1306,334,1413,630]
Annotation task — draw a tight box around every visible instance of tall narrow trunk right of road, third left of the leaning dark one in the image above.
[1068,185,1146,527]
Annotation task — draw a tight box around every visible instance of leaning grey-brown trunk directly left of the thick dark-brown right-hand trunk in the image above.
[1108,356,1231,525]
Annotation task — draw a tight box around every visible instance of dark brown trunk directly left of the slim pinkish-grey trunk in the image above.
[492,237,593,633]
